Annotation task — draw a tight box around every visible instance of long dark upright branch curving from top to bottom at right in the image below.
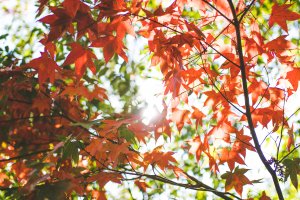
[228,0,284,200]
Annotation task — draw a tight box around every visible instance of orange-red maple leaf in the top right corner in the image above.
[269,3,300,32]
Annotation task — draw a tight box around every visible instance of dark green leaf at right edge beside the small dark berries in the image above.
[282,158,300,190]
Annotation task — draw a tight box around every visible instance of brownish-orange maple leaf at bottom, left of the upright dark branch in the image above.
[221,167,252,196]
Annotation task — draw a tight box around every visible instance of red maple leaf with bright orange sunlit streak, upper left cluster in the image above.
[63,42,97,78]
